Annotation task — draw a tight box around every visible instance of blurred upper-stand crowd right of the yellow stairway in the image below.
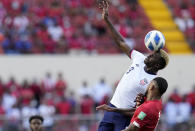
[165,0,195,51]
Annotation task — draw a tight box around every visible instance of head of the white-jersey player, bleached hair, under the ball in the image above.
[144,49,169,71]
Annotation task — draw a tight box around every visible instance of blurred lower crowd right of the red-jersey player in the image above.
[163,86,195,131]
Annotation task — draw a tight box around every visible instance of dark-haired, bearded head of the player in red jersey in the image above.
[146,77,168,97]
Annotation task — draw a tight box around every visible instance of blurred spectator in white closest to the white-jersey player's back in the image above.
[92,78,112,106]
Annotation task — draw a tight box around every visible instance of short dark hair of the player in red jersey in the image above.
[153,77,168,96]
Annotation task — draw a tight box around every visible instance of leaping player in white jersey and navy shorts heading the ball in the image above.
[98,0,169,131]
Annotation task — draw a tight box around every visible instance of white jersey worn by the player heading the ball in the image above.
[110,50,156,108]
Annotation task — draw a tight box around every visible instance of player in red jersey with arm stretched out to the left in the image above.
[97,77,168,131]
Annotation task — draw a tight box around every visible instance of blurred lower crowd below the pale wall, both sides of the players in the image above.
[0,73,195,131]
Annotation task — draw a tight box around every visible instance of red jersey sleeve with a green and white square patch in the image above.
[132,108,150,128]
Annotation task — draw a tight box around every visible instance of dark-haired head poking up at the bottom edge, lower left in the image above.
[29,115,44,131]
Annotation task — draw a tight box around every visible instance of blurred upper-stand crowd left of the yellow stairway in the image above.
[0,0,152,54]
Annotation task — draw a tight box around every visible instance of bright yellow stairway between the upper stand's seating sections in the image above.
[139,0,191,54]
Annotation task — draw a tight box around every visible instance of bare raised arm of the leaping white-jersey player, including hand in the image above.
[99,0,132,56]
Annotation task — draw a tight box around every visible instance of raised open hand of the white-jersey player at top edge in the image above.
[98,0,109,20]
